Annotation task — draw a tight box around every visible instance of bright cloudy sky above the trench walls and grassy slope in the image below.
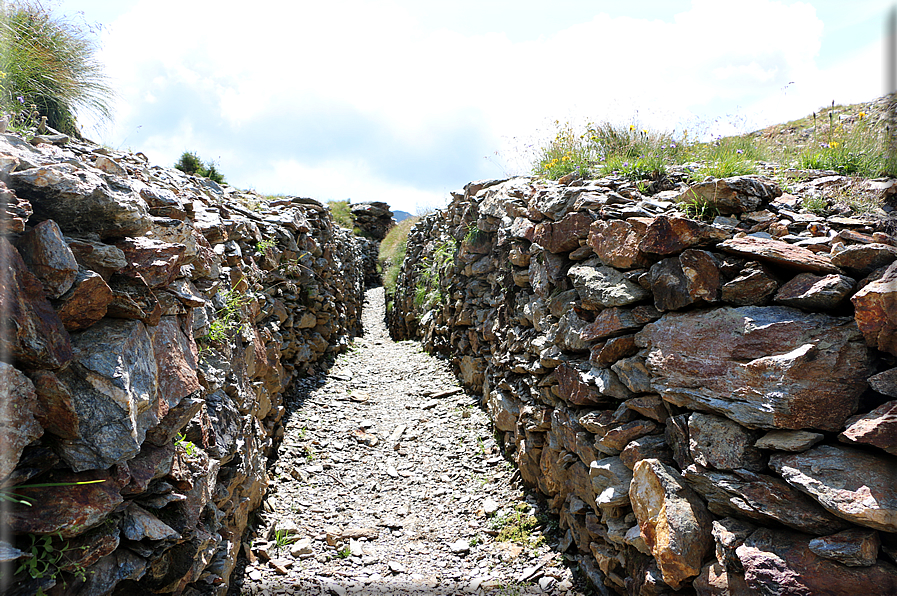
[54,0,893,213]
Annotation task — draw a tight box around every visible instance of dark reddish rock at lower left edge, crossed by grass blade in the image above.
[2,470,123,538]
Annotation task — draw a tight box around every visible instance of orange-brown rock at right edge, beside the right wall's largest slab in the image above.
[850,263,897,355]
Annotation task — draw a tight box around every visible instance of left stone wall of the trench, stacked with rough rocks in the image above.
[0,134,364,596]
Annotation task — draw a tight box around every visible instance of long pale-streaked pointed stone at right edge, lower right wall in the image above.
[769,445,897,532]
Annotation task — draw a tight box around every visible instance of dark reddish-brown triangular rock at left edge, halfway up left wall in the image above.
[0,238,72,369]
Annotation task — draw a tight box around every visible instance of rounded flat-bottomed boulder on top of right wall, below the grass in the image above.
[676,175,782,215]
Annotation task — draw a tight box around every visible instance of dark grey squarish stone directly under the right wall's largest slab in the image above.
[688,412,766,472]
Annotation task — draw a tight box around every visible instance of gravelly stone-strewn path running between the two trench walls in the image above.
[230,288,589,596]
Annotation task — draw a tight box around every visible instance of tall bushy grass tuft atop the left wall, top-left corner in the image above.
[0,0,114,137]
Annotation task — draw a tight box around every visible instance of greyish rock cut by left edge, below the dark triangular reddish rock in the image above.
[0,362,44,480]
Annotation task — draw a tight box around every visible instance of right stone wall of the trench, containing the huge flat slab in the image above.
[387,172,897,596]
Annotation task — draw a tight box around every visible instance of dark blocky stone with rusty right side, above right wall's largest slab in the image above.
[649,249,720,311]
